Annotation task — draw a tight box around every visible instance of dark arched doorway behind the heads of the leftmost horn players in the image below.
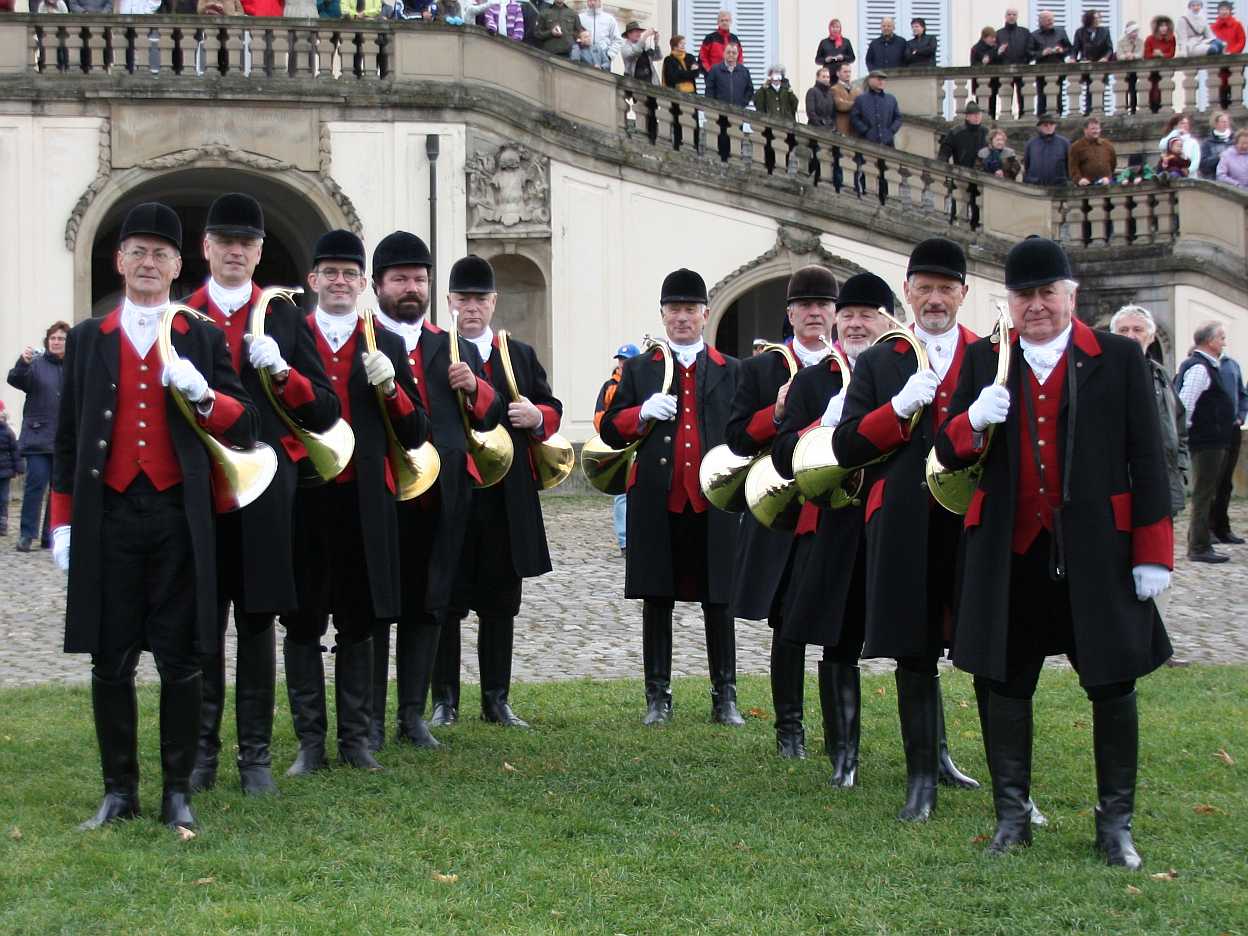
[91,167,331,316]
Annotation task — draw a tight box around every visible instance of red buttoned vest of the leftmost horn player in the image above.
[104,336,182,492]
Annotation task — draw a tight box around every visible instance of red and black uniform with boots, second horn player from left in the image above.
[183,285,341,789]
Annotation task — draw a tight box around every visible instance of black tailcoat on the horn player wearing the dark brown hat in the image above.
[725,351,794,620]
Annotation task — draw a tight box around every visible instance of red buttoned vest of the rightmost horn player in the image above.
[1011,354,1068,555]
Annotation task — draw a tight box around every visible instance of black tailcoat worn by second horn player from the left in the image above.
[182,286,342,613]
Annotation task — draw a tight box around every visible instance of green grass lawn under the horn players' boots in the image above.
[0,666,1248,935]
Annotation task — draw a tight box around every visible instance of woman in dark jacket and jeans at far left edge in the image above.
[9,322,70,553]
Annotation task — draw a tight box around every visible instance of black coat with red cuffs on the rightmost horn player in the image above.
[936,323,1171,685]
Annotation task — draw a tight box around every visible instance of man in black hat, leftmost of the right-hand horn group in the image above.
[602,270,744,725]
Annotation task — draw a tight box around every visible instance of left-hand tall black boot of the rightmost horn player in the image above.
[982,690,1032,855]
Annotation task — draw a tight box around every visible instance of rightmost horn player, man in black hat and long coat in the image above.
[936,237,1174,869]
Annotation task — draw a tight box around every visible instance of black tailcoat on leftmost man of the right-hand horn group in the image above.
[602,346,738,604]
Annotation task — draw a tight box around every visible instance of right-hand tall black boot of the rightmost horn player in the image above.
[1092,690,1143,871]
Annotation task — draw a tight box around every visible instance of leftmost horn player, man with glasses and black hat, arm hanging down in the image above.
[51,202,258,829]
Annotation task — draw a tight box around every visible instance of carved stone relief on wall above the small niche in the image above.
[466,142,550,236]
